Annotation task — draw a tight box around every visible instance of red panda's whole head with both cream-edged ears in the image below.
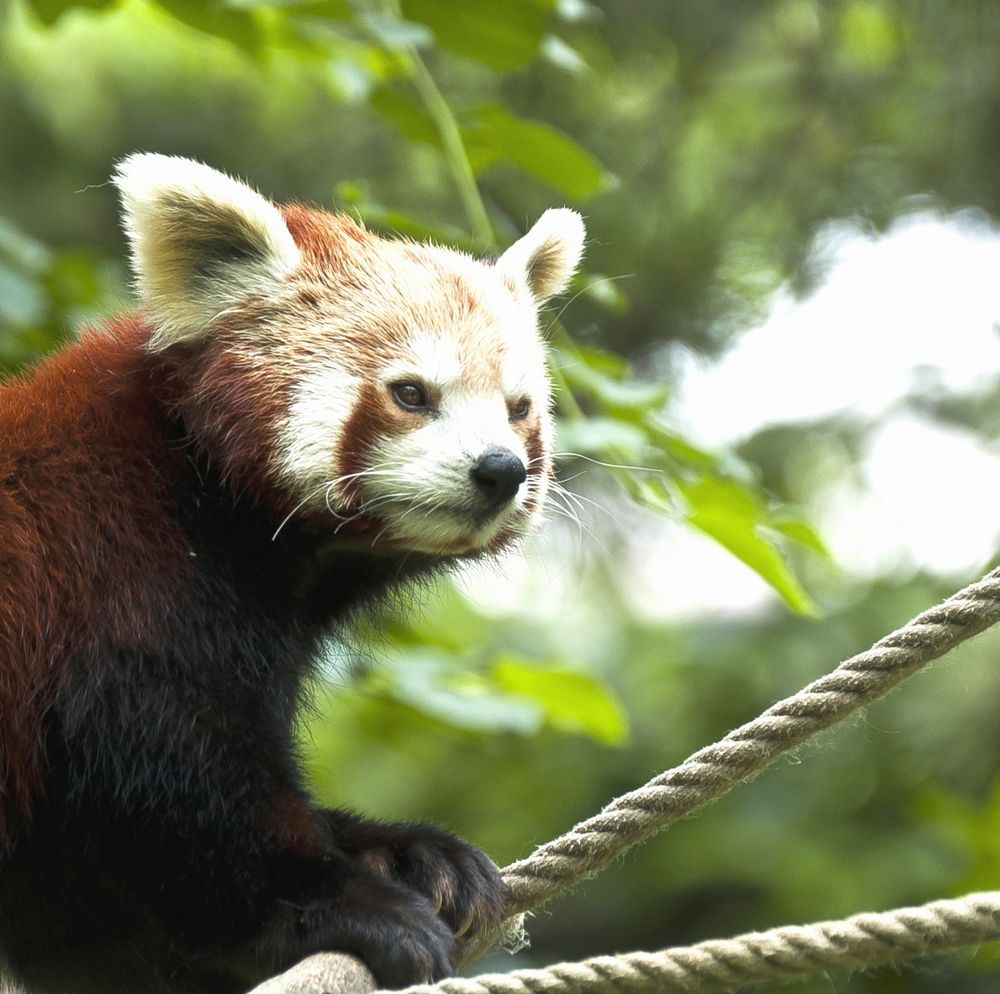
[115,154,584,555]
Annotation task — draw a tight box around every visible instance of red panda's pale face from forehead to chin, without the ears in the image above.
[270,236,552,555]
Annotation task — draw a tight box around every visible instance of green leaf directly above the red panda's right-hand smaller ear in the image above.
[462,104,613,200]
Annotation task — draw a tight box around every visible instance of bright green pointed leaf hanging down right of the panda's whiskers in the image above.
[680,477,819,617]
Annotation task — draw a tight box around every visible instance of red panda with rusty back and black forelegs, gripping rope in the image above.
[0,154,584,994]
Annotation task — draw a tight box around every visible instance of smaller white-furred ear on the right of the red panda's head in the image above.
[497,207,585,304]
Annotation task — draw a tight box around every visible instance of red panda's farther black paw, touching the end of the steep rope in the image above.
[329,811,507,937]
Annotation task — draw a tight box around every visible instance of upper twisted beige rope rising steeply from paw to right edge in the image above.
[504,569,1000,916]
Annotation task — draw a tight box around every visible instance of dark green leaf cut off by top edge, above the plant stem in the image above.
[402,0,553,69]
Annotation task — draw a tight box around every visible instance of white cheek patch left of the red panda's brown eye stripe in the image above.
[277,363,361,506]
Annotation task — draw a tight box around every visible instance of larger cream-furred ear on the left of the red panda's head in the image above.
[114,153,300,349]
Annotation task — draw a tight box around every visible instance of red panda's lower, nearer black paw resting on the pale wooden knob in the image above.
[265,876,455,990]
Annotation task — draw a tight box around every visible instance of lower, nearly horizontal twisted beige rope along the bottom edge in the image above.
[401,891,1000,994]
